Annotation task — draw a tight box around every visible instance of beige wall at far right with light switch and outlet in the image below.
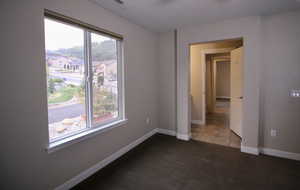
[261,11,300,153]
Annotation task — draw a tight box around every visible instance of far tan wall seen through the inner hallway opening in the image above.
[216,61,230,97]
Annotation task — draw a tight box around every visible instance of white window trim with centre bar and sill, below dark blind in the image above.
[45,13,128,153]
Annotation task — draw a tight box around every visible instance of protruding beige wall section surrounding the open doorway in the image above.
[177,16,261,147]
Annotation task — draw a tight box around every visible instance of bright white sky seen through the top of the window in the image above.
[45,18,109,50]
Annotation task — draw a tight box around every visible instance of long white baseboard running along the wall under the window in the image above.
[55,129,157,190]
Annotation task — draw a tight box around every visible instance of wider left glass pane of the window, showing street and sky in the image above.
[45,18,86,141]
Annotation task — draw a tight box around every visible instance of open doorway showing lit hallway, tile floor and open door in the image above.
[190,39,243,148]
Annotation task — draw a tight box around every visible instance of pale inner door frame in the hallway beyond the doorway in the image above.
[200,48,235,125]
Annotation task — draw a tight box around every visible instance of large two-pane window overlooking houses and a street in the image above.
[44,13,124,143]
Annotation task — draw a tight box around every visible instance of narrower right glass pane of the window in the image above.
[91,33,118,126]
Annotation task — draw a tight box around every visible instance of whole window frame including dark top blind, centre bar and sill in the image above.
[43,9,127,153]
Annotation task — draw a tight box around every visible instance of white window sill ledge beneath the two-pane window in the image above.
[47,119,128,153]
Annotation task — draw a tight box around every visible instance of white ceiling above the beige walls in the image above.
[90,0,300,32]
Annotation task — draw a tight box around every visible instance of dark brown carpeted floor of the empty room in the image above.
[74,135,300,190]
